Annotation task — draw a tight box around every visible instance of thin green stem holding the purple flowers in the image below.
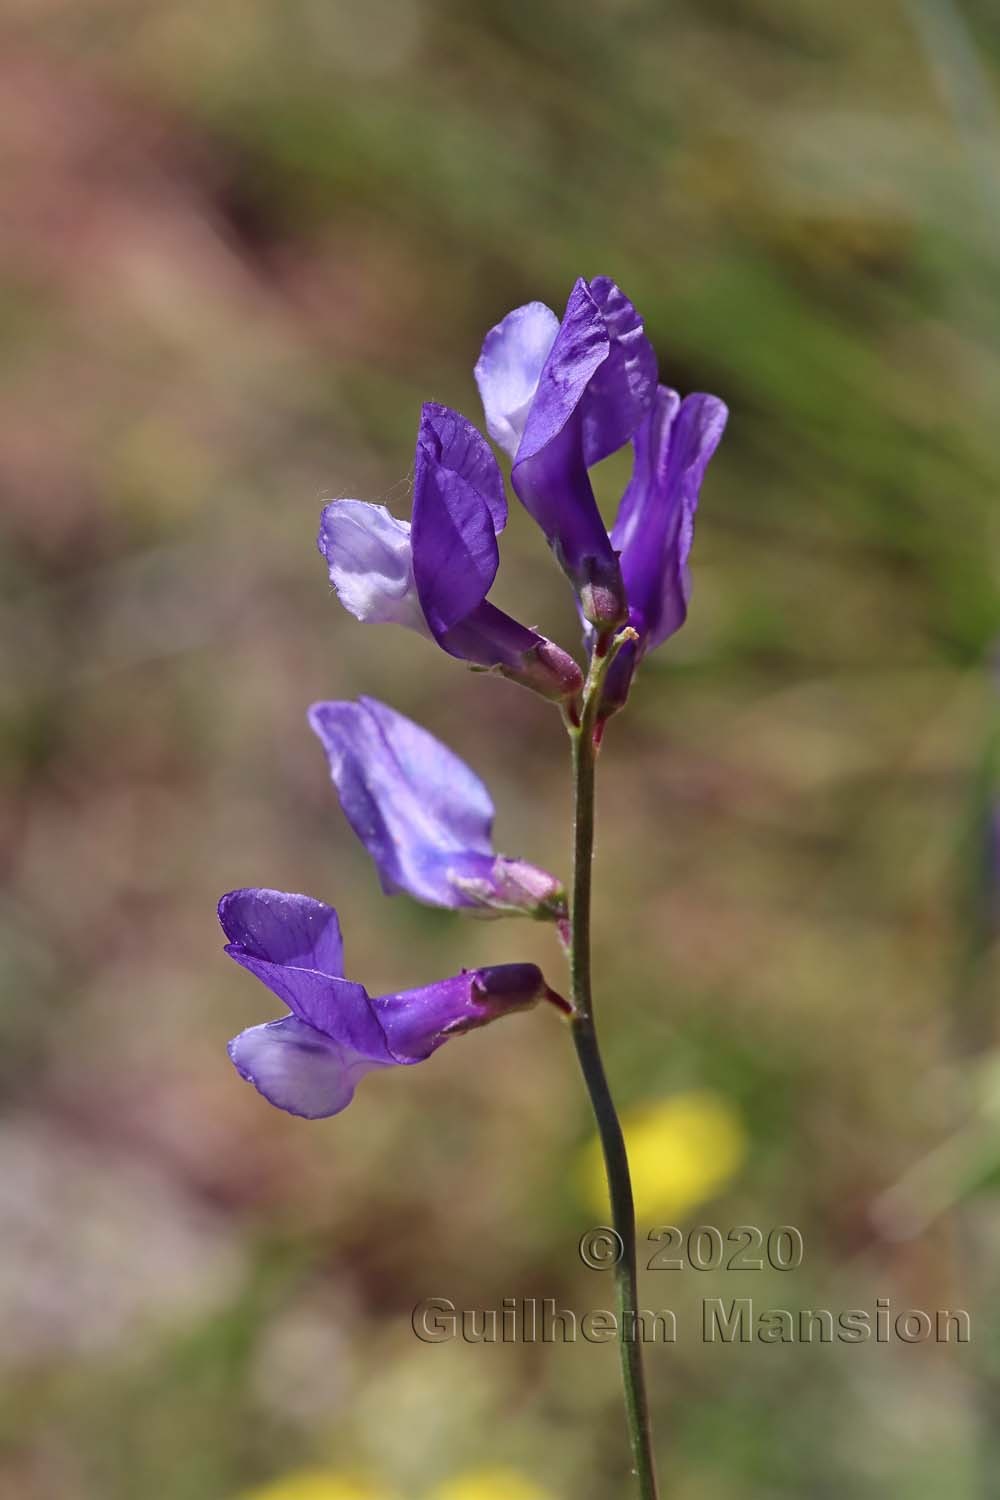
[567,630,658,1500]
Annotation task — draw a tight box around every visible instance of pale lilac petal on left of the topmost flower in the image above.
[475,302,559,459]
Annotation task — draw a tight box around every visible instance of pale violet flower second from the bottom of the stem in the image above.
[309,698,565,920]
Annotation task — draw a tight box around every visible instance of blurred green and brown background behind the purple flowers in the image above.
[0,0,1000,1500]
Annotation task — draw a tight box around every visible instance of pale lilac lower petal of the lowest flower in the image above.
[229,1016,391,1119]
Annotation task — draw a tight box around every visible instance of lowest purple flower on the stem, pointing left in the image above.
[219,891,562,1119]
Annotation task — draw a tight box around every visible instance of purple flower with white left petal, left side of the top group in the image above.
[318,402,582,701]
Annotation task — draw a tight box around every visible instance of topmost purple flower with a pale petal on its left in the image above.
[475,276,657,630]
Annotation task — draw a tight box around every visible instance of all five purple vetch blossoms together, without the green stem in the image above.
[219,276,727,1118]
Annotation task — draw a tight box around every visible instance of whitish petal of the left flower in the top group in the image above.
[316,500,430,636]
